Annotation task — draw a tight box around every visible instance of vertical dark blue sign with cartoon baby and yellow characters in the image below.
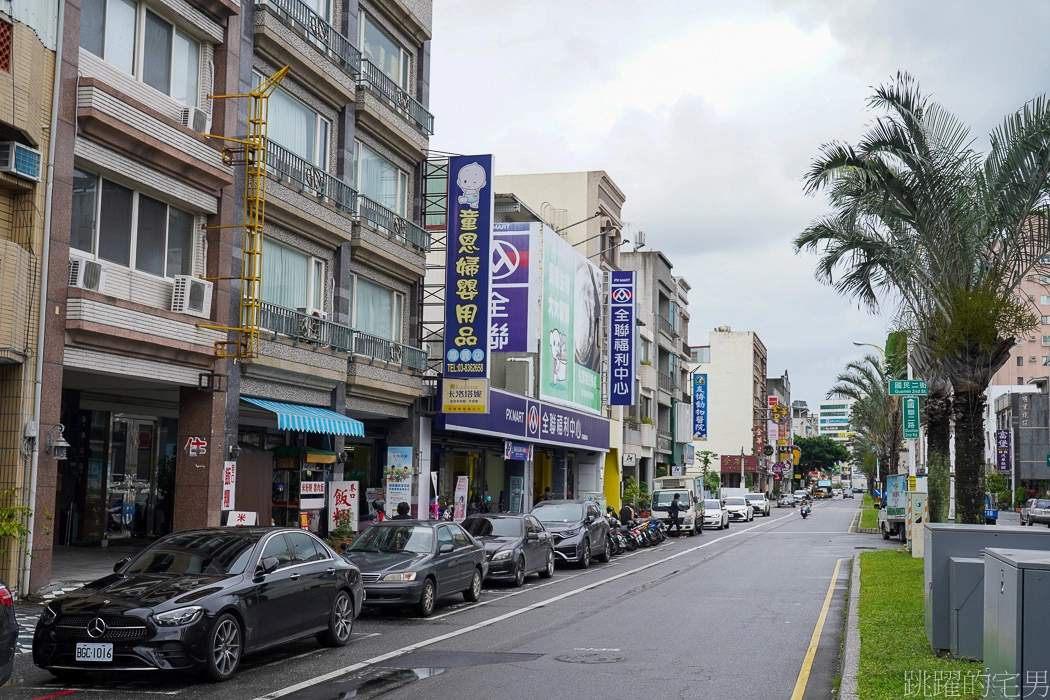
[443,155,494,379]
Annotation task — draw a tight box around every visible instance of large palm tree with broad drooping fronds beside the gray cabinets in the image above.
[795,73,1050,523]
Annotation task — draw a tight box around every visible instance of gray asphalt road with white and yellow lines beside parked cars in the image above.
[4,501,891,700]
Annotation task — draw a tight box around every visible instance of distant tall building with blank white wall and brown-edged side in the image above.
[691,326,769,487]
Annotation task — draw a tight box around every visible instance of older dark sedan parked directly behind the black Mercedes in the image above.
[347,519,486,617]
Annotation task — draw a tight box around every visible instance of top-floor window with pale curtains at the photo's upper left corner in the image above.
[80,0,201,107]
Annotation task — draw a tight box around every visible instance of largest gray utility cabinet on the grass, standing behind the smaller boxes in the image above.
[923,523,1050,651]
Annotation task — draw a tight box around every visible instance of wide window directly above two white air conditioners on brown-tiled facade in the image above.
[69,170,194,277]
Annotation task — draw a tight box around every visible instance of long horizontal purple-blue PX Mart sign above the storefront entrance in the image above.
[439,389,609,452]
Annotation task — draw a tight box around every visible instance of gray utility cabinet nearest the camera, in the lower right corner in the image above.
[984,548,1050,700]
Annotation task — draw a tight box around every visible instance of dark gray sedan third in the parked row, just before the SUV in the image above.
[463,513,554,586]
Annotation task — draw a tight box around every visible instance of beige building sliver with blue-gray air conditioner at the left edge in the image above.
[0,2,63,593]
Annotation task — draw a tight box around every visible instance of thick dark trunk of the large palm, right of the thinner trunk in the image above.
[954,388,986,525]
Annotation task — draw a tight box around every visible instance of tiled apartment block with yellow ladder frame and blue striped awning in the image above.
[33,0,433,588]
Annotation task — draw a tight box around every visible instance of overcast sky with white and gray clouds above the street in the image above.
[431,0,1050,407]
